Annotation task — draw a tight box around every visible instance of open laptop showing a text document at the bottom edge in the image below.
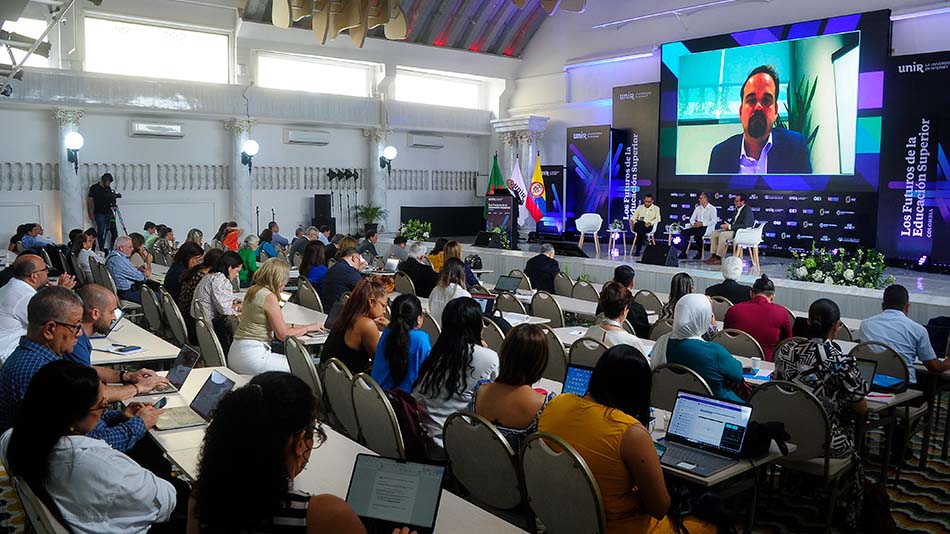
[346,454,445,534]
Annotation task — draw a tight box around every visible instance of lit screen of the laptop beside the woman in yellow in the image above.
[666,391,752,458]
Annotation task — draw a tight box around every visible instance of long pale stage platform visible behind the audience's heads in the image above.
[376,235,950,324]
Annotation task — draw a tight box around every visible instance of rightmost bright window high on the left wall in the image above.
[395,67,485,109]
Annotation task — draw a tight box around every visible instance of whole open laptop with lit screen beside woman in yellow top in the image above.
[660,391,752,477]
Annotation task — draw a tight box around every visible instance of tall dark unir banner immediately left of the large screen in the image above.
[610,82,660,220]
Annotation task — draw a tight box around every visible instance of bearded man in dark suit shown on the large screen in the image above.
[709,65,811,174]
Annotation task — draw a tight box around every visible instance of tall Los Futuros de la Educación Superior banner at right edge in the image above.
[877,52,950,266]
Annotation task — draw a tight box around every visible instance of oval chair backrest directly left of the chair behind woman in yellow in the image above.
[442,411,524,510]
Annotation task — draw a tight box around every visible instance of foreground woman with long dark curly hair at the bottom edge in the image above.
[188,372,366,534]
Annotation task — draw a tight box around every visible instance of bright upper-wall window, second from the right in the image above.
[257,53,382,98]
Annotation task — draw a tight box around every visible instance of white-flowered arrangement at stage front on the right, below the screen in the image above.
[788,243,894,289]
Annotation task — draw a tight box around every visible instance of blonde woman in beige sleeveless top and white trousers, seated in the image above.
[228,258,323,375]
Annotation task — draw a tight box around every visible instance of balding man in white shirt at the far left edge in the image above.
[0,254,76,362]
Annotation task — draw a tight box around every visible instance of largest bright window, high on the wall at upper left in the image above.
[85,17,230,83]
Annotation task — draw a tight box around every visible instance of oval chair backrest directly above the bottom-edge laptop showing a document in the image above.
[352,373,406,459]
